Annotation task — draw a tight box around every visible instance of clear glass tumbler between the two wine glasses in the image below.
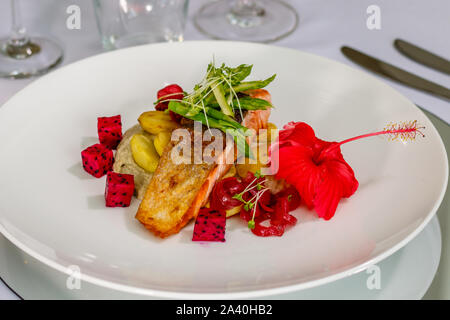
[94,0,189,50]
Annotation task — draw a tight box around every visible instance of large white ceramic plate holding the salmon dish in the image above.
[0,42,448,298]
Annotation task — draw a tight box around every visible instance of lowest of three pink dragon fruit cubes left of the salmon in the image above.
[105,171,134,207]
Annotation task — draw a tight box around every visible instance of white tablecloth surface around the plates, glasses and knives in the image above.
[0,0,450,299]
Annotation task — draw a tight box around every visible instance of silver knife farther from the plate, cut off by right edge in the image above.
[394,39,450,74]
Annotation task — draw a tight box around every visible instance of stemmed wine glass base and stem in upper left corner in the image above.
[0,0,63,78]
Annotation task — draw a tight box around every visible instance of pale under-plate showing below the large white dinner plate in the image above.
[0,217,441,300]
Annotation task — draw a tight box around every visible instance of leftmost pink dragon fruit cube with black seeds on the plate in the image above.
[81,143,114,178]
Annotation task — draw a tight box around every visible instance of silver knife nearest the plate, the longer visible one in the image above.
[341,46,450,100]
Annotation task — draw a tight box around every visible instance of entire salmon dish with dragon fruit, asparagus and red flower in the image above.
[82,59,424,242]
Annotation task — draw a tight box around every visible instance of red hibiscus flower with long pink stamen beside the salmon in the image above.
[272,121,423,220]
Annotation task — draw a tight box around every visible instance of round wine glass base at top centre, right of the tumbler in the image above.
[194,0,299,42]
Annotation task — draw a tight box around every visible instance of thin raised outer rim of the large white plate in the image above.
[0,40,449,299]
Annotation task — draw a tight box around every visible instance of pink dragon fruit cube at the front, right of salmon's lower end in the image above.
[192,208,226,242]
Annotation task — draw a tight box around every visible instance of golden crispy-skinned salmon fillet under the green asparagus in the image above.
[136,89,271,238]
